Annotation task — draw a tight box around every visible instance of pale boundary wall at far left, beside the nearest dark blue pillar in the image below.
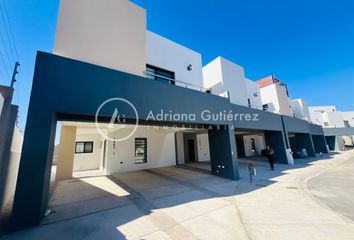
[0,125,23,210]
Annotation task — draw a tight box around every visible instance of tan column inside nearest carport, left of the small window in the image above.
[55,126,76,181]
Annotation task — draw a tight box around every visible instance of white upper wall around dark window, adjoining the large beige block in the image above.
[146,31,203,90]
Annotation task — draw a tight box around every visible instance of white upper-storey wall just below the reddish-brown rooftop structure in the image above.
[260,83,293,117]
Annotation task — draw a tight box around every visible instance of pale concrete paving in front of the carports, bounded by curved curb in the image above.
[3,151,354,240]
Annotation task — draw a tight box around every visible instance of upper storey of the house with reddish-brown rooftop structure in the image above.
[257,75,293,117]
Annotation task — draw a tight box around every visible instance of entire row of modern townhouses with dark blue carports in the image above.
[4,0,348,231]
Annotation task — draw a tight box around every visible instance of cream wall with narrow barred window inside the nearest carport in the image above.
[107,127,176,174]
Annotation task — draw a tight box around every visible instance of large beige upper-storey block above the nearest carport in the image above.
[53,0,146,76]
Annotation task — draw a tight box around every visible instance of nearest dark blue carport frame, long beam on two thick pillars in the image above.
[12,52,239,229]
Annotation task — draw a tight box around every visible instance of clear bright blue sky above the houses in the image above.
[0,0,354,129]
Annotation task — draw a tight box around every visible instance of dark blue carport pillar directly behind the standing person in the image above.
[264,131,288,164]
